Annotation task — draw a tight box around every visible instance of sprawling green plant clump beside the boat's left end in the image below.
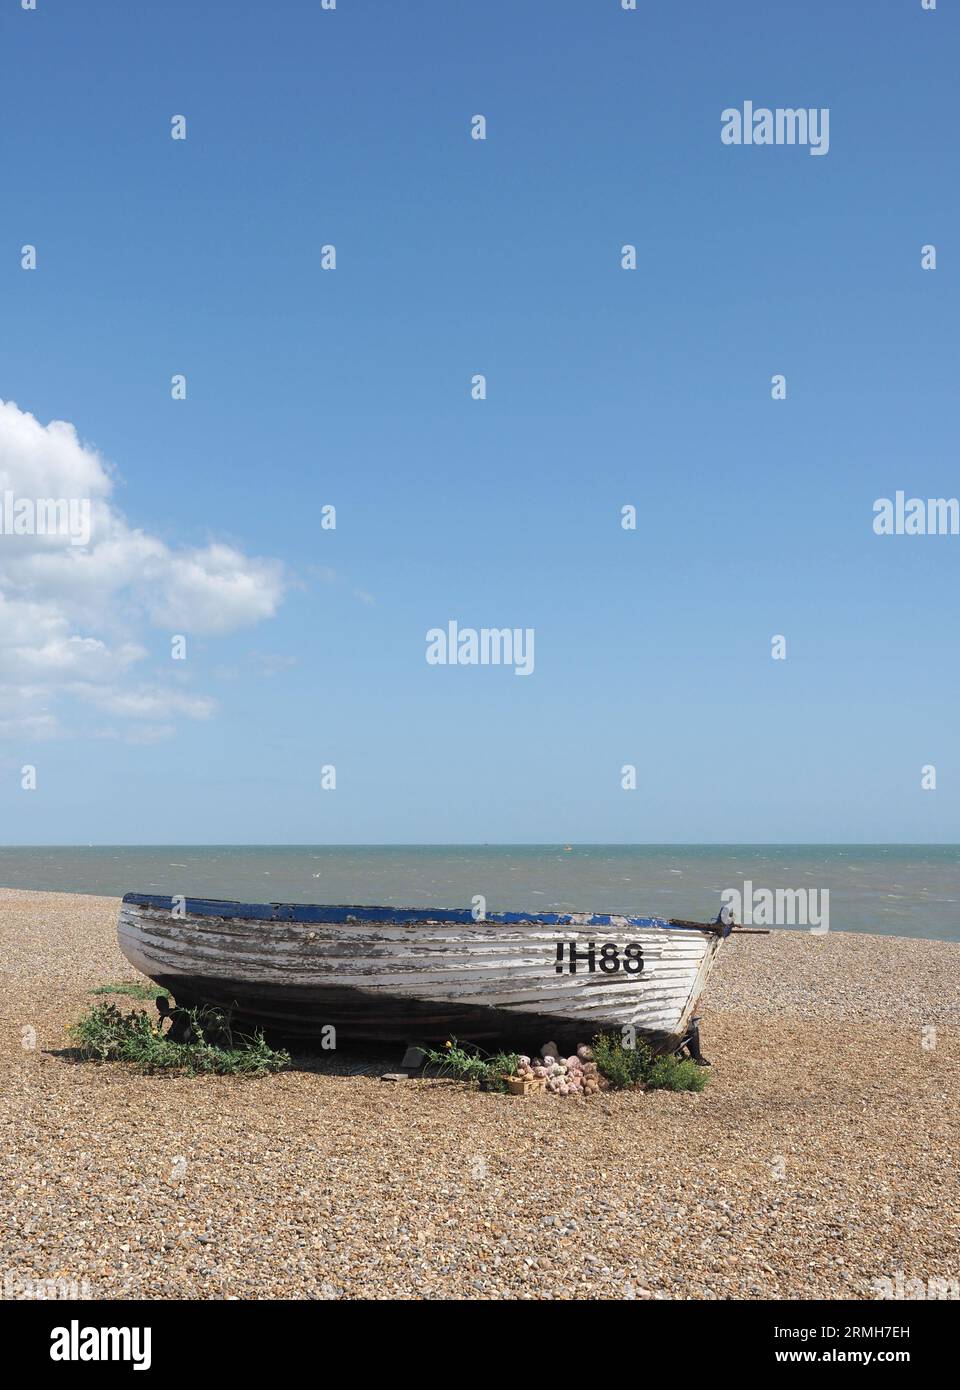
[71,1004,290,1076]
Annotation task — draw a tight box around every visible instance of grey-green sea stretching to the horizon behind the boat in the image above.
[0,845,960,941]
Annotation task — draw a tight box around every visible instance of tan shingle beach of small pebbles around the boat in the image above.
[0,890,960,1300]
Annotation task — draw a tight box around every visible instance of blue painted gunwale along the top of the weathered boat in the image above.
[124,892,729,935]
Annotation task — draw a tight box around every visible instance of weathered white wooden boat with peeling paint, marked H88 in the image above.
[118,892,731,1048]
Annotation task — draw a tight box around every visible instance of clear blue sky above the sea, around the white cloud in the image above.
[0,0,960,844]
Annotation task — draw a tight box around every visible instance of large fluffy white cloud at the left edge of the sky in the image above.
[0,402,285,738]
